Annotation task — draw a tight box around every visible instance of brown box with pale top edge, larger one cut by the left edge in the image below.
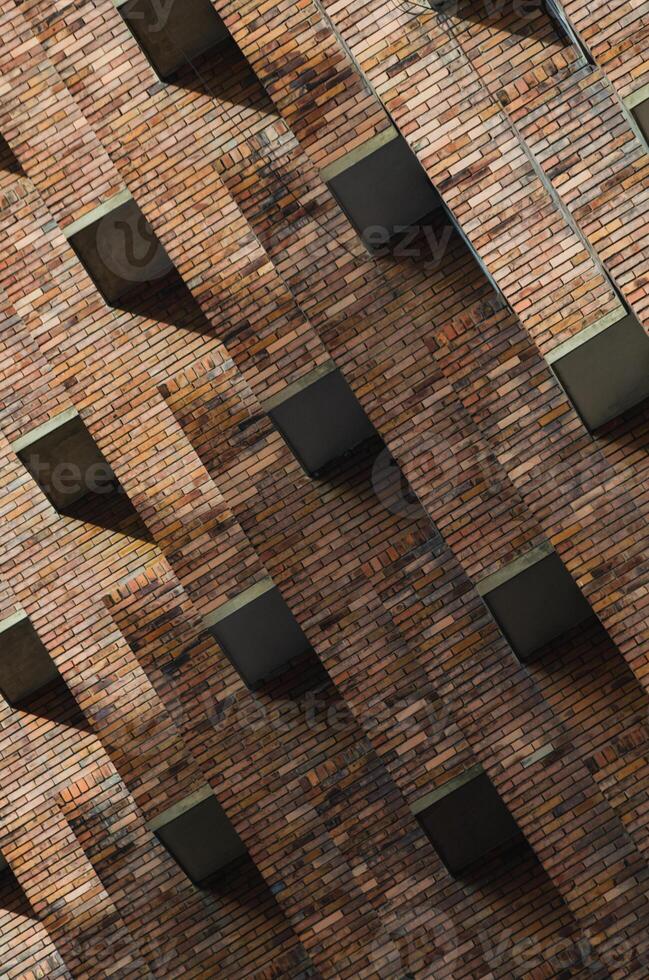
[0,612,61,707]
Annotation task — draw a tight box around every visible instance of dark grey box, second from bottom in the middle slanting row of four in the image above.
[205,578,310,687]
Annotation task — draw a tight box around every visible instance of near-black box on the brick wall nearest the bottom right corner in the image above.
[413,766,525,875]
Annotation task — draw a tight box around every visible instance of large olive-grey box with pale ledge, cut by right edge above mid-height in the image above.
[548,314,649,432]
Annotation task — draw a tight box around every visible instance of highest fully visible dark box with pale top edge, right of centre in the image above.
[322,128,441,251]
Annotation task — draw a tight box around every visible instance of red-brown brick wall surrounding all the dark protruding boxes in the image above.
[0,0,649,980]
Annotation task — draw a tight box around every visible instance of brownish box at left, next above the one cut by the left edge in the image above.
[12,408,118,513]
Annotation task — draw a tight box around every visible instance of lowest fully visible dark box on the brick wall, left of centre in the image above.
[149,786,247,885]
